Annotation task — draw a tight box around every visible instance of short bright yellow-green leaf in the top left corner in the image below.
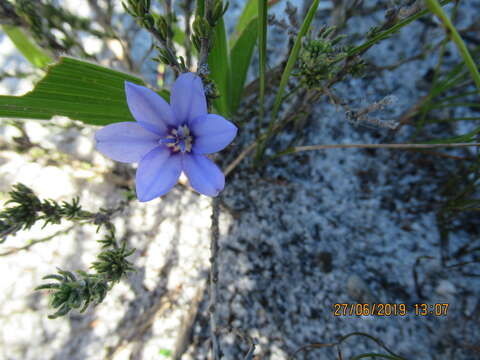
[2,25,53,68]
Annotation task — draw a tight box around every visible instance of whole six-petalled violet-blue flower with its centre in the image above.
[95,73,237,201]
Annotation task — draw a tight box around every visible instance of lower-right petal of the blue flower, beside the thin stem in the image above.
[183,154,225,196]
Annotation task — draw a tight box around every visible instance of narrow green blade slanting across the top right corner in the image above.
[425,0,480,90]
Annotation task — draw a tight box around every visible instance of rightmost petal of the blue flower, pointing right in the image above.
[190,114,237,154]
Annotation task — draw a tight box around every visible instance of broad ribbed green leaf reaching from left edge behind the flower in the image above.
[0,57,148,125]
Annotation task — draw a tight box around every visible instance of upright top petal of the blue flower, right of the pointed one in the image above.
[170,73,207,125]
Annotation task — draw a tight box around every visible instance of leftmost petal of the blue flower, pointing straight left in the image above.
[95,122,159,163]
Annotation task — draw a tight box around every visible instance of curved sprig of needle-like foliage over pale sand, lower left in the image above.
[0,184,135,319]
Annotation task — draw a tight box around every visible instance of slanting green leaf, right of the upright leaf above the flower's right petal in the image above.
[230,18,258,113]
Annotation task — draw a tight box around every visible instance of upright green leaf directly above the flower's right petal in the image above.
[208,18,231,116]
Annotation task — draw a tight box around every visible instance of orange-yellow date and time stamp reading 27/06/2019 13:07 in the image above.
[333,303,449,316]
